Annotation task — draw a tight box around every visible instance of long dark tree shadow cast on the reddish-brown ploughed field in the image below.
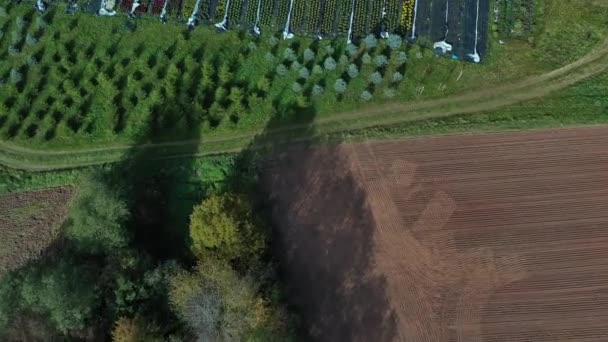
[232,95,398,341]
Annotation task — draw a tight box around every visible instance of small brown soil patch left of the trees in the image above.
[0,188,73,275]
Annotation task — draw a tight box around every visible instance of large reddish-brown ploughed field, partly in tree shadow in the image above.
[261,127,608,342]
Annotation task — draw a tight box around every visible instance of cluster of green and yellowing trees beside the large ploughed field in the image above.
[0,170,292,341]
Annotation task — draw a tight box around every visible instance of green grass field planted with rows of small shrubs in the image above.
[0,0,608,191]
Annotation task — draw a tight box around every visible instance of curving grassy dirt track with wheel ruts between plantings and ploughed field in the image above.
[0,39,608,171]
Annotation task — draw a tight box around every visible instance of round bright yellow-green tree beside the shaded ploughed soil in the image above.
[190,194,265,264]
